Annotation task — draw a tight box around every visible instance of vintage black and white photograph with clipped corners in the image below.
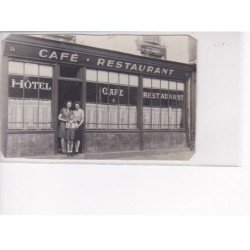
[1,33,197,160]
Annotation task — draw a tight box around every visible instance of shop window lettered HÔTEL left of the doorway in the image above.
[8,61,53,130]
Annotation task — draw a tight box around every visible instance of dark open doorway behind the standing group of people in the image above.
[57,80,83,153]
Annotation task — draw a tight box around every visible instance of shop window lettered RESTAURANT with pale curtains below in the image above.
[143,78,185,129]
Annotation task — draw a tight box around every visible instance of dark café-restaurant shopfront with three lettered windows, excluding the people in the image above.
[1,34,196,158]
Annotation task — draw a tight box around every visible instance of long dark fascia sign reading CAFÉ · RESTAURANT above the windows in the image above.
[5,41,190,80]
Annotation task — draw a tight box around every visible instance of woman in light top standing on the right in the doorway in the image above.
[73,101,84,154]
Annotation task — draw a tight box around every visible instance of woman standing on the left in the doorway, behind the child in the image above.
[58,101,73,154]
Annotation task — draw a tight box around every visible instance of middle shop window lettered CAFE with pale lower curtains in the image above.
[86,70,138,129]
